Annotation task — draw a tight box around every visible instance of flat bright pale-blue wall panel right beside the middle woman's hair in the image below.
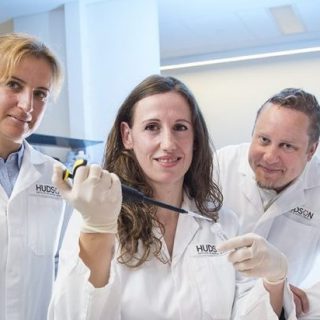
[85,0,160,139]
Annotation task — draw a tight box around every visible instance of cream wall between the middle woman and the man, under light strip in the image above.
[162,53,320,154]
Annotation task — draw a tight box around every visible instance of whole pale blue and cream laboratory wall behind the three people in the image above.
[0,0,320,154]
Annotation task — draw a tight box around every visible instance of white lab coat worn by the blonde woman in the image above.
[0,143,65,320]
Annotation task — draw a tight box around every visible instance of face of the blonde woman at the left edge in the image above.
[0,56,52,145]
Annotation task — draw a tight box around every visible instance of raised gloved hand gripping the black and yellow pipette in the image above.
[52,165,122,233]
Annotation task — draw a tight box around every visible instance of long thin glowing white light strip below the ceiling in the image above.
[160,47,320,71]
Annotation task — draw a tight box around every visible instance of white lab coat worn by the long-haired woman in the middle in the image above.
[48,196,295,320]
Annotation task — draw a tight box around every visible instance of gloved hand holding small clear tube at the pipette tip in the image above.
[217,233,288,283]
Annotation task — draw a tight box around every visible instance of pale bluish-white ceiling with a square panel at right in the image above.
[0,0,320,65]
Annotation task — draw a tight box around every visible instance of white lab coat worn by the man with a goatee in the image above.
[218,143,320,318]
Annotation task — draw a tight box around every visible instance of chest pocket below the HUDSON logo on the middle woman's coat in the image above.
[193,255,235,320]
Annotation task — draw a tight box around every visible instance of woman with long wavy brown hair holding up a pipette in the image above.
[49,76,292,320]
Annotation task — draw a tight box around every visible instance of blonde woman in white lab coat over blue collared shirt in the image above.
[0,34,65,320]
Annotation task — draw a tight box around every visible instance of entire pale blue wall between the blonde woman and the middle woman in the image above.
[8,0,160,162]
